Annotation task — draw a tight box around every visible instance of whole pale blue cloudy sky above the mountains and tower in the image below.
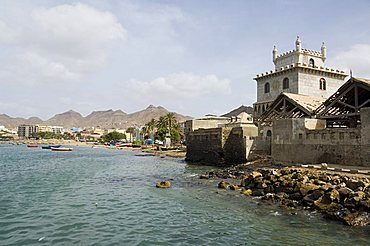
[0,0,370,120]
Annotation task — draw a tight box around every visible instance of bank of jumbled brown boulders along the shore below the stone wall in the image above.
[200,162,370,226]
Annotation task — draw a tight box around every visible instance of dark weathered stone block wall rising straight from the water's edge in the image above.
[186,126,258,166]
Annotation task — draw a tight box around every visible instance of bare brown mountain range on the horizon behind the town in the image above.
[0,105,192,129]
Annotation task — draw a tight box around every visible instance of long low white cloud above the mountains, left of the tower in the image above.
[128,72,231,99]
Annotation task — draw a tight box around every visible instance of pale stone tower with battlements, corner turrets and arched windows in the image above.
[253,37,348,120]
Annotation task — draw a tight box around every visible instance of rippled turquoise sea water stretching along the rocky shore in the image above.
[0,144,370,245]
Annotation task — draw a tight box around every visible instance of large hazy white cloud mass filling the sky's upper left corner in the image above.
[0,3,127,84]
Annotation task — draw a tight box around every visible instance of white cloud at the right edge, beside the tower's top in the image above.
[332,44,370,78]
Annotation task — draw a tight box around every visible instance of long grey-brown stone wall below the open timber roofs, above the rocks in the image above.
[272,109,370,166]
